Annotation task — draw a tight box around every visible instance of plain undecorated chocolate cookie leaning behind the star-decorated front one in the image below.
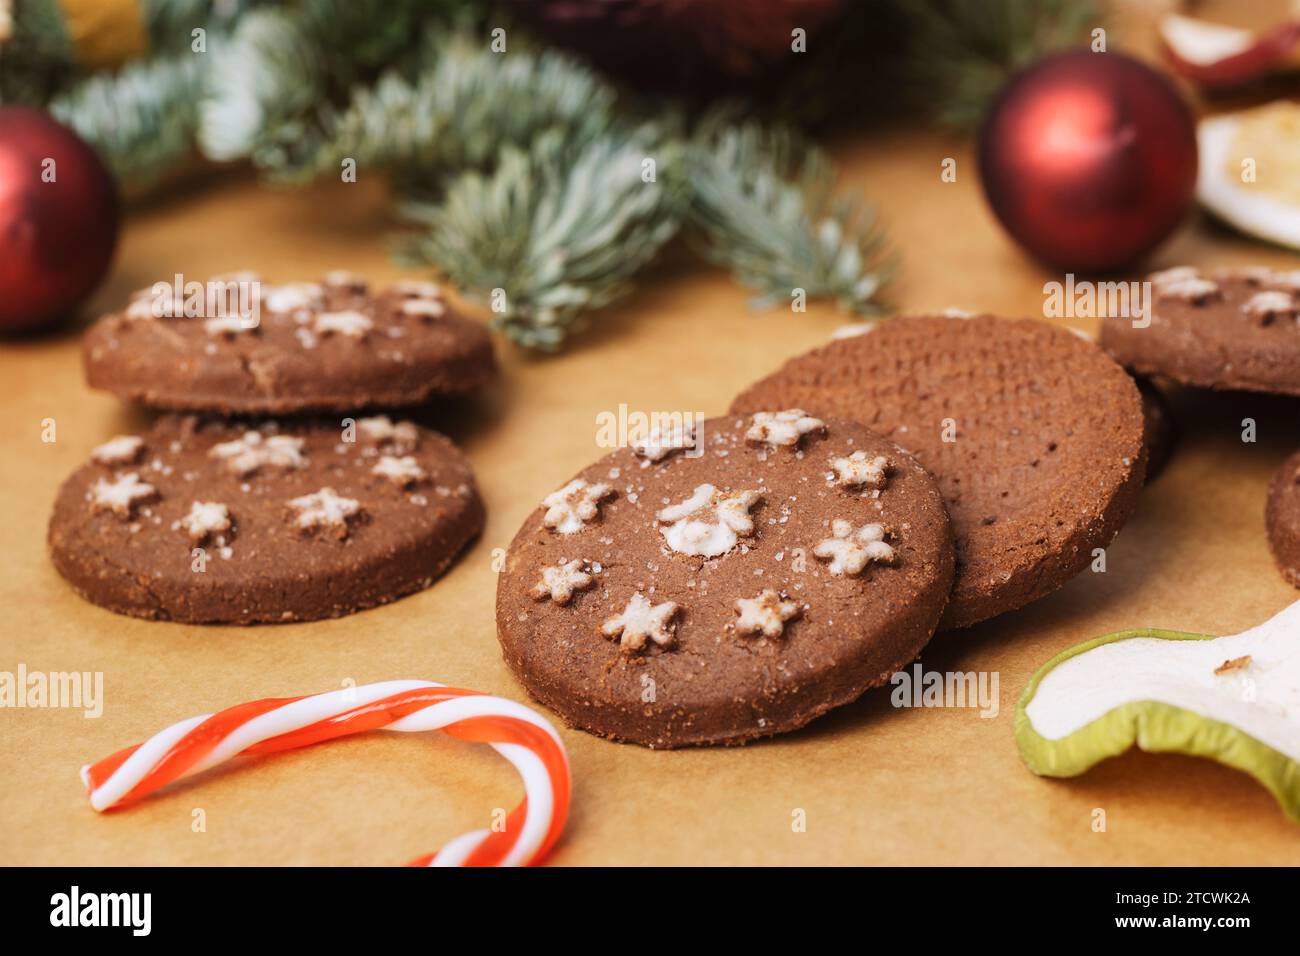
[732,316,1145,627]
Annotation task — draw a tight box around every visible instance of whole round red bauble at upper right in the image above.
[979,51,1196,272]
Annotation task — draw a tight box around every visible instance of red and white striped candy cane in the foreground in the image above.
[81,680,569,866]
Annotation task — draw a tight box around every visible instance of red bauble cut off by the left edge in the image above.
[0,107,118,332]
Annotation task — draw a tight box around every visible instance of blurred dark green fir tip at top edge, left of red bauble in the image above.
[901,0,1100,131]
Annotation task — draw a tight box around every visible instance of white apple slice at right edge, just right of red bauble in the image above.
[1196,101,1300,248]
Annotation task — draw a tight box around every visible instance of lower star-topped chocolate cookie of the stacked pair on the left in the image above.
[49,415,484,624]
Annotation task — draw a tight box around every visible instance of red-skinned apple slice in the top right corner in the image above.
[1160,13,1300,87]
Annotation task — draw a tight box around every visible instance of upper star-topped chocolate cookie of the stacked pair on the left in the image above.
[83,272,495,415]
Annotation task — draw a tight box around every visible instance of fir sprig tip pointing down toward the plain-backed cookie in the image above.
[689,121,891,313]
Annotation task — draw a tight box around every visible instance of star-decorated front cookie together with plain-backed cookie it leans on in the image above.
[497,315,1147,748]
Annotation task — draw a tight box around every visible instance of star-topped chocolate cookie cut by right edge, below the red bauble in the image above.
[1101,265,1300,395]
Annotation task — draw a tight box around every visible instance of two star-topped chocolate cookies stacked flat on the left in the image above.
[49,272,495,624]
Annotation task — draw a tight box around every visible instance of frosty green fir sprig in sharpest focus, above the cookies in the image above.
[400,129,681,350]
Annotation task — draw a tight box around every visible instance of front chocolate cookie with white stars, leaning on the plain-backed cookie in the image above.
[497,410,953,748]
